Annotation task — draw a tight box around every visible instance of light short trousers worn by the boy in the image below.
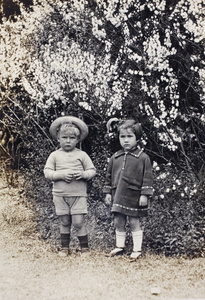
[53,195,88,216]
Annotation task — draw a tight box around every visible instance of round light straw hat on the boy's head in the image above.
[49,116,88,142]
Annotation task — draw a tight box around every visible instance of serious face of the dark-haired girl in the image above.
[119,128,137,151]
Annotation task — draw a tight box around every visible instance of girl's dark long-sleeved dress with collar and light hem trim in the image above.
[103,148,153,217]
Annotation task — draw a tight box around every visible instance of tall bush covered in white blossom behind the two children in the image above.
[0,0,205,252]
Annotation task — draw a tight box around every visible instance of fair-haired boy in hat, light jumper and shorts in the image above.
[44,116,96,256]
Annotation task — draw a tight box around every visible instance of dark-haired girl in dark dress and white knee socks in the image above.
[104,120,153,259]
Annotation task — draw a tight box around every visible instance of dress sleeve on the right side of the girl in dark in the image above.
[141,156,153,196]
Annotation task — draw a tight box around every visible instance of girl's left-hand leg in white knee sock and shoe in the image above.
[110,213,126,256]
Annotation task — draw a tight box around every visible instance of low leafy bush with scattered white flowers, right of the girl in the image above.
[145,162,205,257]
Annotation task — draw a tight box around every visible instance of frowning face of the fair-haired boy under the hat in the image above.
[58,130,79,152]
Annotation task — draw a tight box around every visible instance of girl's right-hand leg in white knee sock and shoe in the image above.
[129,217,143,259]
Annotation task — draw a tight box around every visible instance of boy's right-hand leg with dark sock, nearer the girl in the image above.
[72,214,88,251]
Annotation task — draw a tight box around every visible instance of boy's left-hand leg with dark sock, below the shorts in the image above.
[60,215,71,255]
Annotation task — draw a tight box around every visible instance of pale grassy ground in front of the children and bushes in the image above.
[0,185,205,300]
